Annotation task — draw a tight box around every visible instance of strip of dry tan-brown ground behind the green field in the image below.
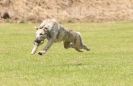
[0,0,133,22]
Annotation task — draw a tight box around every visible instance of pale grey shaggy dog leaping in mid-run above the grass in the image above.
[31,19,90,55]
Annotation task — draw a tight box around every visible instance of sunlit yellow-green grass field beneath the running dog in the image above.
[0,22,133,86]
